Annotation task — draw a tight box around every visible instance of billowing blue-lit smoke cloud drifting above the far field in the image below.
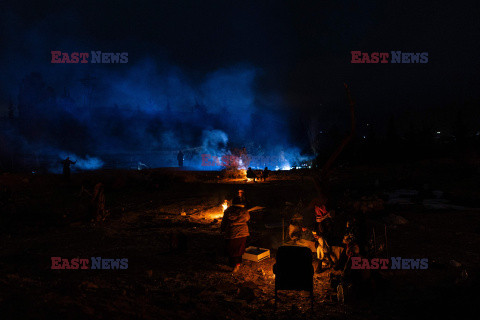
[0,13,312,170]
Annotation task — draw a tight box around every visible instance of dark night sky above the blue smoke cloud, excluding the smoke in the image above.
[0,0,480,138]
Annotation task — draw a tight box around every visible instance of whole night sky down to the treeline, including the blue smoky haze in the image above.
[0,1,480,164]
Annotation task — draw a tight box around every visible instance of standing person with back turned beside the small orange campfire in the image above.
[220,197,250,273]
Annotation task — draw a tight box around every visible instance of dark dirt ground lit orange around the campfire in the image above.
[0,160,480,319]
